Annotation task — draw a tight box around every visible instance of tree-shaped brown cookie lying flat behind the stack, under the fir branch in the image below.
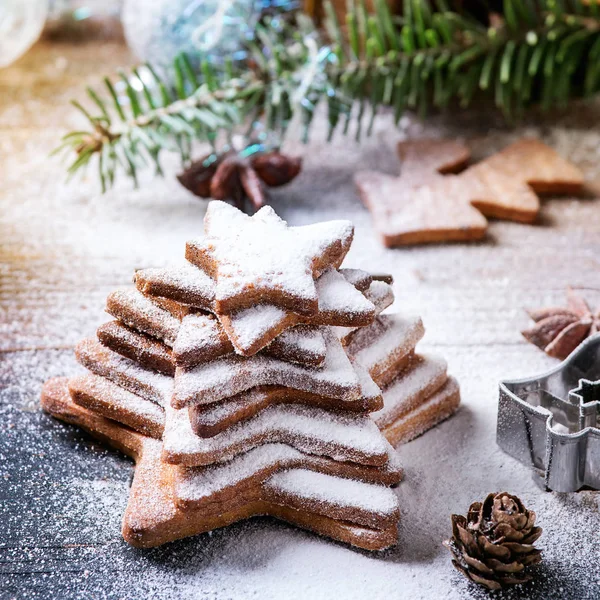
[355,139,583,246]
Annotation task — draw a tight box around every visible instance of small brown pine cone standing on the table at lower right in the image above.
[444,492,542,590]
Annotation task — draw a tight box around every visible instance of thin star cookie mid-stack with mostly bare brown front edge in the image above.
[188,365,383,437]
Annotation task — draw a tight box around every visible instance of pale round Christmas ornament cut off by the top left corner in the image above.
[0,0,48,68]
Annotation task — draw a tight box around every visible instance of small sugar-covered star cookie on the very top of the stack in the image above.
[186,201,354,315]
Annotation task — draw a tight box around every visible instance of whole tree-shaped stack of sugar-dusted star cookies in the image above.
[42,202,457,550]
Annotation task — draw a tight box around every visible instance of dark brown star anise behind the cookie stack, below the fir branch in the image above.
[177,151,302,210]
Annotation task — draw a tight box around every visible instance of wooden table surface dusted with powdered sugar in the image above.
[0,42,600,599]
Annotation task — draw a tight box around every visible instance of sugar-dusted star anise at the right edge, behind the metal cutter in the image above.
[521,288,600,360]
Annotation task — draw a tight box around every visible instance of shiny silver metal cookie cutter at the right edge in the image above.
[496,333,600,492]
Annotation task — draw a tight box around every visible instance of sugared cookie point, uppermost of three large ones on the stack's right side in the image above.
[348,314,425,388]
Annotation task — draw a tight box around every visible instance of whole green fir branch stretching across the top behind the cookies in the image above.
[57,0,600,190]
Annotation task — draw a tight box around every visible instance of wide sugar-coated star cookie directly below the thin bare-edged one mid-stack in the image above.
[163,404,388,466]
